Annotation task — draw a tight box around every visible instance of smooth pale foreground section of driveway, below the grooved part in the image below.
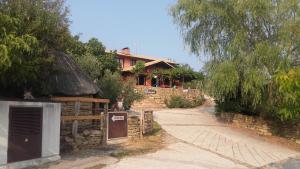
[104,142,247,169]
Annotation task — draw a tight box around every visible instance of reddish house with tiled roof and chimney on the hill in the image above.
[117,47,180,87]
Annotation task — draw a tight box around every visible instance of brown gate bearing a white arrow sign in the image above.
[108,112,128,139]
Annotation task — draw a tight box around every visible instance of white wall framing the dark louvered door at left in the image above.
[0,101,61,165]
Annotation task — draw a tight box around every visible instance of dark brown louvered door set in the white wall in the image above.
[7,107,43,163]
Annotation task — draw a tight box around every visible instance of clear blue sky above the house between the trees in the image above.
[66,0,203,70]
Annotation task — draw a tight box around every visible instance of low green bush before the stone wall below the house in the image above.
[165,96,204,108]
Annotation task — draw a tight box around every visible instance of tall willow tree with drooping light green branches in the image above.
[171,0,300,119]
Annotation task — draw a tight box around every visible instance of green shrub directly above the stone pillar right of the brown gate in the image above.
[122,80,143,110]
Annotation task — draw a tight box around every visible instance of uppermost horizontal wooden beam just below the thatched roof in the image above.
[51,97,110,103]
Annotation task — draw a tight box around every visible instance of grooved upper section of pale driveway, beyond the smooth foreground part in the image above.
[156,106,299,168]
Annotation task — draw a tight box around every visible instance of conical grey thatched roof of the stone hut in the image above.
[50,52,99,96]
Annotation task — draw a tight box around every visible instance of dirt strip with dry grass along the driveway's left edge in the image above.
[27,123,176,169]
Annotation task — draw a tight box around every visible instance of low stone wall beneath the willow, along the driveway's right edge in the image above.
[217,112,300,144]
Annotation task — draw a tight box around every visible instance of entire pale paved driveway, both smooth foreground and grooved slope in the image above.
[106,103,299,169]
